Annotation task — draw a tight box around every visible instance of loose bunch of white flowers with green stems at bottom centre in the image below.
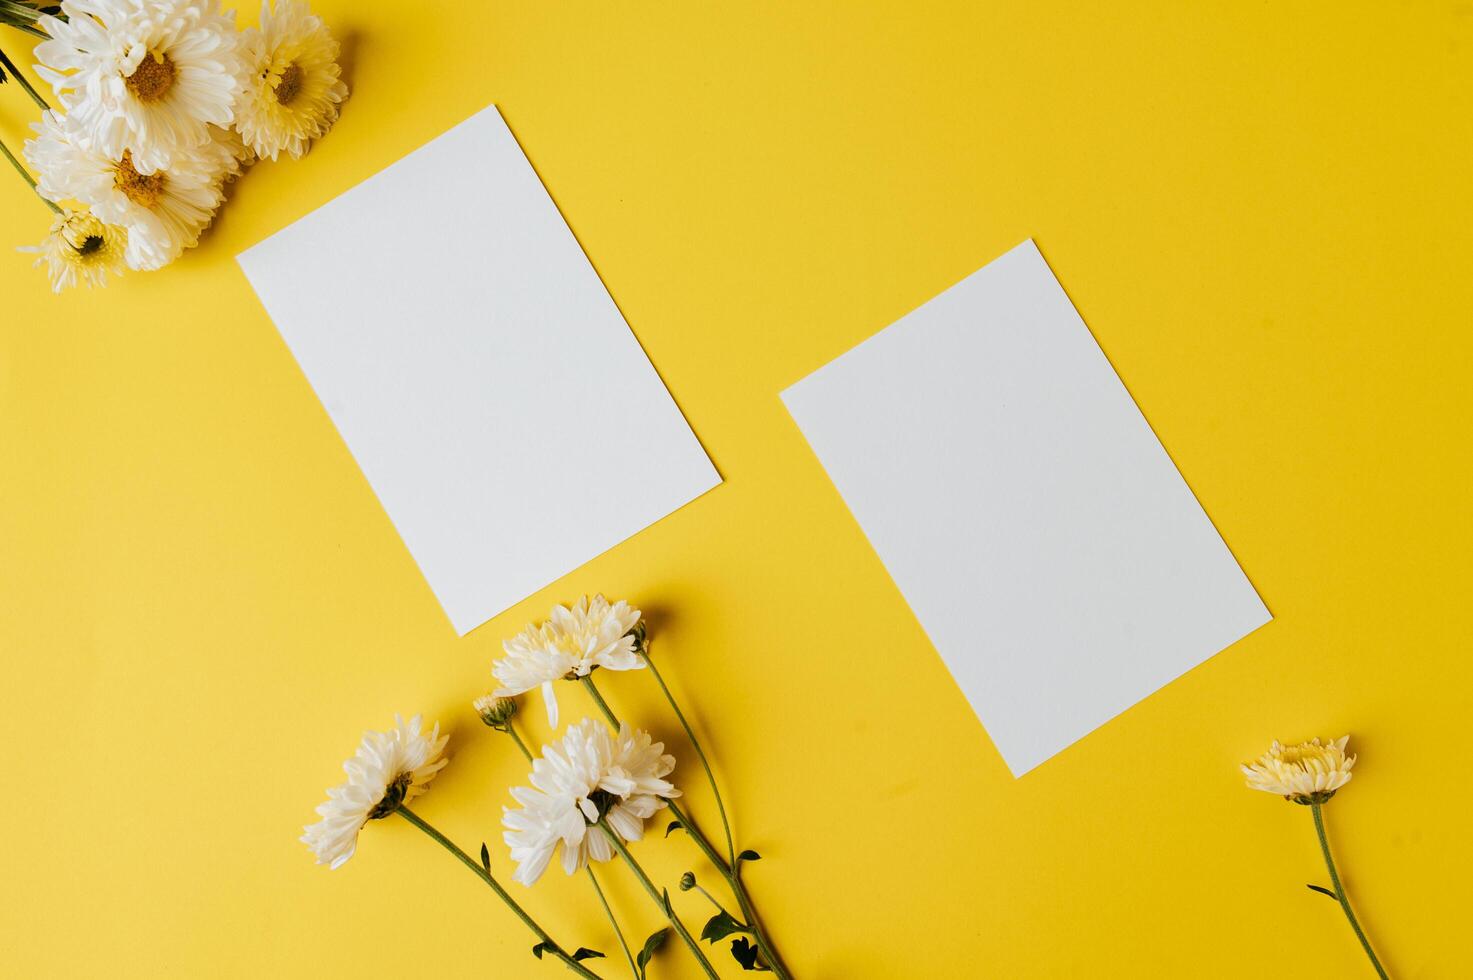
[302,595,792,980]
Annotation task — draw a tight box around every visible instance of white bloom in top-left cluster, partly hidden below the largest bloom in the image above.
[25,112,227,270]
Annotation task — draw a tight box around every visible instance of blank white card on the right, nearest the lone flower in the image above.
[782,242,1270,775]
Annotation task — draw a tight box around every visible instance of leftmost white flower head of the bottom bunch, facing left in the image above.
[302,715,449,869]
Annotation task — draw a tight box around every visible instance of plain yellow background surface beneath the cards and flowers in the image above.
[0,0,1473,979]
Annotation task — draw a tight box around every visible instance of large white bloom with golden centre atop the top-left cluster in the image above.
[35,0,245,174]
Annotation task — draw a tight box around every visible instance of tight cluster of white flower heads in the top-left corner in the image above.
[25,0,348,292]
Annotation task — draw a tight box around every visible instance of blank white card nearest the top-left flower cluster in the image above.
[239,108,720,634]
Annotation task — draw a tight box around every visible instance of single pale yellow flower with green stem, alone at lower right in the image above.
[1242,735,1389,980]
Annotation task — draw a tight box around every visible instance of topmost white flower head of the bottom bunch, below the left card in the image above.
[491,595,644,727]
